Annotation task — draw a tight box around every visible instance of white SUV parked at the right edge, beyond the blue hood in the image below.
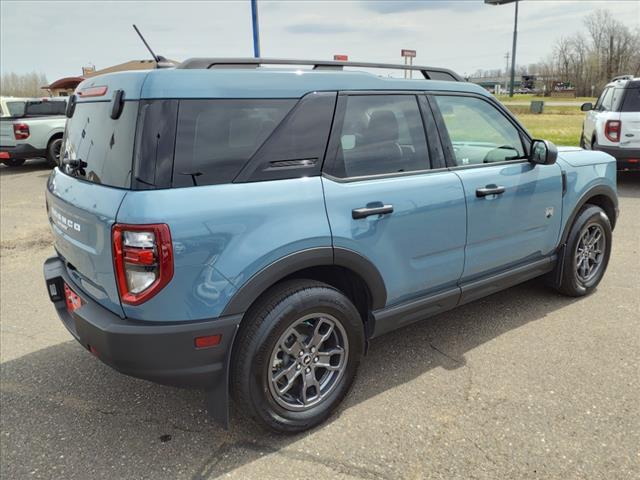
[580,75,640,170]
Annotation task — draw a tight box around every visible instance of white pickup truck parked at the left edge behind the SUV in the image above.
[0,98,67,167]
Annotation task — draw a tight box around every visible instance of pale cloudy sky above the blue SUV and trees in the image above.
[0,0,640,81]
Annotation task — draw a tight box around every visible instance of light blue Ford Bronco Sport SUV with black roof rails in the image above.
[44,58,618,432]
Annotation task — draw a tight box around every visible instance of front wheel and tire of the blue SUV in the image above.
[557,204,612,297]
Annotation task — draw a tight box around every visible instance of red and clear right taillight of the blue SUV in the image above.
[112,223,173,305]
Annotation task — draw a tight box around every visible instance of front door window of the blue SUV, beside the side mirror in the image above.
[434,95,526,165]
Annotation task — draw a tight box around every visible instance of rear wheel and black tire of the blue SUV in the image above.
[231,280,364,433]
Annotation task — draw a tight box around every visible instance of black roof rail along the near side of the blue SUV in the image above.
[176,58,464,82]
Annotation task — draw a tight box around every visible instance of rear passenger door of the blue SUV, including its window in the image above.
[322,93,466,312]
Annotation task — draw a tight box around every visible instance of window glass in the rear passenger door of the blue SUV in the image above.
[331,95,429,177]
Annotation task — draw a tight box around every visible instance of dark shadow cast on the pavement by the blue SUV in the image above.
[1,281,576,479]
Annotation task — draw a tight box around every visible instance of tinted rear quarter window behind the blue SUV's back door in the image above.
[173,99,296,186]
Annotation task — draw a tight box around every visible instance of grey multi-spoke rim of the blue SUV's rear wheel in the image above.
[268,313,349,411]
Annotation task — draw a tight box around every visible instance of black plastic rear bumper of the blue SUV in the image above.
[44,256,242,423]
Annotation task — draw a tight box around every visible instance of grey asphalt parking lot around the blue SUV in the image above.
[0,159,640,480]
